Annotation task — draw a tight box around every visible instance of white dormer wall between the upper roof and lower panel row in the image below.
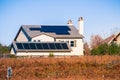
[32,35,54,42]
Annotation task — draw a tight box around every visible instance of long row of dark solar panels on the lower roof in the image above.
[16,42,69,51]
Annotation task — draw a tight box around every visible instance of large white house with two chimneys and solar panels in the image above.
[10,17,84,56]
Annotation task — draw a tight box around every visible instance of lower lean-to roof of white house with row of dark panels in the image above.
[12,41,71,52]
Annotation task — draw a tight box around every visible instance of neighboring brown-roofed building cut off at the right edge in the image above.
[103,33,120,45]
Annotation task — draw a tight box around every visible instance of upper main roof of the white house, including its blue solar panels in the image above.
[21,25,83,38]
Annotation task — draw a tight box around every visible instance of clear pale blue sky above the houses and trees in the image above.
[0,0,120,45]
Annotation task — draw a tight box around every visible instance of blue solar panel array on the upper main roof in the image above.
[30,26,70,35]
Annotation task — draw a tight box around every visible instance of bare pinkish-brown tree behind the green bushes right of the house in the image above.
[90,35,103,49]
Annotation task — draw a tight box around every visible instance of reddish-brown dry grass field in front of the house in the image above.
[0,55,120,80]
